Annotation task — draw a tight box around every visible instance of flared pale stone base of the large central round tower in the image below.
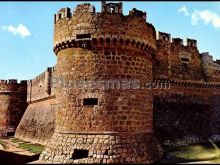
[40,132,162,164]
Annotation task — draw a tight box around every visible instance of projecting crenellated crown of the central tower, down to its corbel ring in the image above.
[54,2,156,54]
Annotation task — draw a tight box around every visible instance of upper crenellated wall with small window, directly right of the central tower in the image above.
[153,32,204,81]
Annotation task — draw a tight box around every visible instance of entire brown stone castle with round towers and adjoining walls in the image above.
[0,2,220,164]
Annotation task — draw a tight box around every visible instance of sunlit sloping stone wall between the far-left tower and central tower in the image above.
[15,99,56,145]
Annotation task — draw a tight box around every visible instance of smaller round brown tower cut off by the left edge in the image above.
[0,80,27,136]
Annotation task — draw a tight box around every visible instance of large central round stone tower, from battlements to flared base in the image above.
[40,2,160,163]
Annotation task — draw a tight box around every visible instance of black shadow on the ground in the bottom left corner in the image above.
[0,150,40,164]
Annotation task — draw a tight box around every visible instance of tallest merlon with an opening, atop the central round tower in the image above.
[102,1,122,14]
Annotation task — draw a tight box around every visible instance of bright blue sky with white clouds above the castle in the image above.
[0,1,220,80]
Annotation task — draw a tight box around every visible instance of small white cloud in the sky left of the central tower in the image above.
[2,24,31,38]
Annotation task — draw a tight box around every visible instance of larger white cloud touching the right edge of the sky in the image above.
[191,10,220,28]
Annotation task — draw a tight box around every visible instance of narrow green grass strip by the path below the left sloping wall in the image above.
[11,138,44,154]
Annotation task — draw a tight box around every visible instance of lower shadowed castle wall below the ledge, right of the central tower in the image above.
[153,79,220,146]
